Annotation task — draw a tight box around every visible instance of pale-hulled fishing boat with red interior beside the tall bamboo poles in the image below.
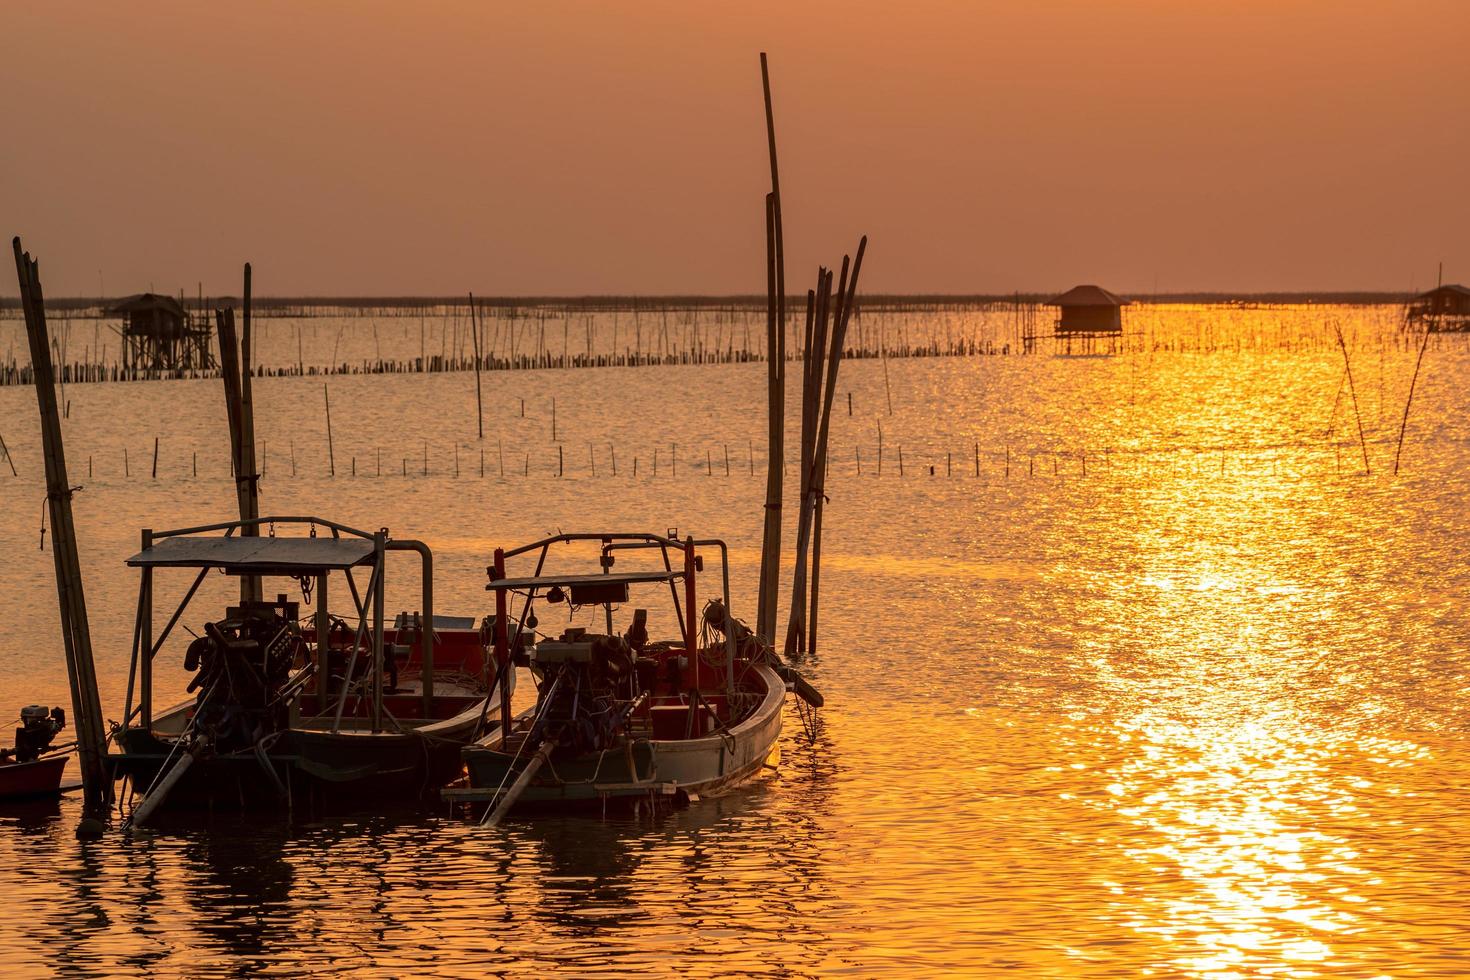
[442,530,822,823]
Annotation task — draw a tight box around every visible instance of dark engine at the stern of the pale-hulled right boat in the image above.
[531,629,634,754]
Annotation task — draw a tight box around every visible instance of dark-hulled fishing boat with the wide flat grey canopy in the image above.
[109,517,513,823]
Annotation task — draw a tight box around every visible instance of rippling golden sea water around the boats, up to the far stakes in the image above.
[0,310,1470,977]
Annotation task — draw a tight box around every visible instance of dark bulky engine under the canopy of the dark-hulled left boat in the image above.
[184,597,301,752]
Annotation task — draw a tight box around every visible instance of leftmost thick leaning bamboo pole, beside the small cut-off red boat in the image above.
[12,238,112,835]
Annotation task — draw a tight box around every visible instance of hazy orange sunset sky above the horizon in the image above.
[0,0,1470,297]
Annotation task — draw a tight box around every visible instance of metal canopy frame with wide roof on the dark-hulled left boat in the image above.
[122,516,438,732]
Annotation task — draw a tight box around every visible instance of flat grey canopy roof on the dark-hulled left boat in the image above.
[128,535,373,576]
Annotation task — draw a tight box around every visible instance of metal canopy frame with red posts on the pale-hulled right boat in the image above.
[485,530,735,738]
